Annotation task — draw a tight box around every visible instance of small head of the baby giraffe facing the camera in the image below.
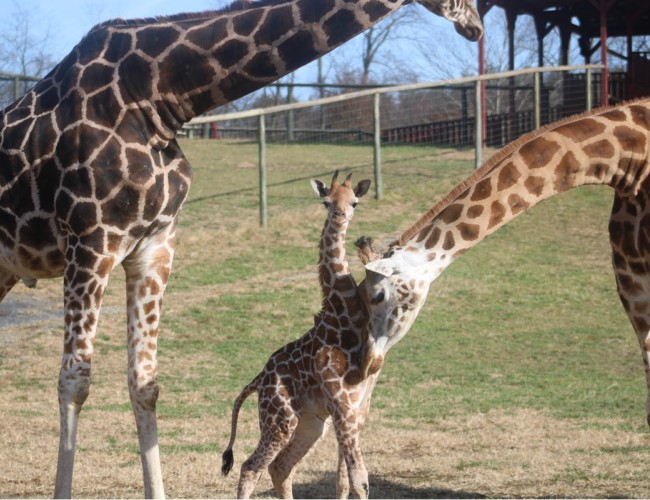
[310,170,370,226]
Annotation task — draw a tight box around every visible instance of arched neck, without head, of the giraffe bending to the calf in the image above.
[394,101,650,281]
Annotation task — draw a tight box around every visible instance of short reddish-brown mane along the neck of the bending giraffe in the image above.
[393,98,647,246]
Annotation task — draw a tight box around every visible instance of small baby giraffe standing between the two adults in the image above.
[221,172,379,498]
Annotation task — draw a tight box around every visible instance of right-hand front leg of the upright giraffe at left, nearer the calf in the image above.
[123,225,174,498]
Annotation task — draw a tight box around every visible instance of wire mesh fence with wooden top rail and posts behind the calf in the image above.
[184,65,602,225]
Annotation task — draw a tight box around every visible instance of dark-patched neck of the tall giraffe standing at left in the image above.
[73,0,412,137]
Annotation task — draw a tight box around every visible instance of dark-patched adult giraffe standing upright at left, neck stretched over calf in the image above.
[0,0,482,497]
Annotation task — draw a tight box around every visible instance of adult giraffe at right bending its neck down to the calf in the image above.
[360,99,650,430]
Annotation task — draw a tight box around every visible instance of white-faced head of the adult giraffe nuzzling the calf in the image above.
[359,249,435,375]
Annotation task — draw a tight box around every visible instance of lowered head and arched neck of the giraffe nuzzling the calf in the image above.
[363,100,650,367]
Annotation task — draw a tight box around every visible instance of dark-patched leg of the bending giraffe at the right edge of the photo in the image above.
[609,194,650,425]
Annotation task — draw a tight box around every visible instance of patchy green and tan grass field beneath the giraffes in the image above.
[0,141,650,498]
